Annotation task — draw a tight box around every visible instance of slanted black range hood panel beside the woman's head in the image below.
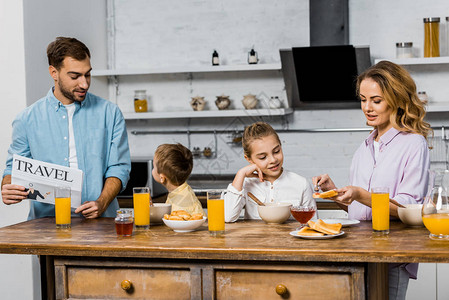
[281,45,371,107]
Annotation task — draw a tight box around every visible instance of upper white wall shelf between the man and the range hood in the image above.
[92,64,281,76]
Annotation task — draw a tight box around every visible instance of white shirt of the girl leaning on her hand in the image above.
[224,169,315,222]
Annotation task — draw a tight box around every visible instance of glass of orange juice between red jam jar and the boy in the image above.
[133,187,151,229]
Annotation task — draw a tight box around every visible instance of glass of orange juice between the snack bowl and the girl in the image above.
[207,190,225,236]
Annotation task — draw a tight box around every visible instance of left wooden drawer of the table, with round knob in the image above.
[66,266,191,300]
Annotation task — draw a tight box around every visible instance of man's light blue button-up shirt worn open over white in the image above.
[3,89,131,219]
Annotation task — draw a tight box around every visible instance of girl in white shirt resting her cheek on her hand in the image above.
[224,122,315,222]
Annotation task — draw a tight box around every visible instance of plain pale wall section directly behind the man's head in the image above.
[23,0,107,105]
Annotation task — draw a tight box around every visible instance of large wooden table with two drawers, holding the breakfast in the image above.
[0,218,449,299]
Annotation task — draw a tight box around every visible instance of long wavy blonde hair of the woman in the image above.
[356,61,433,139]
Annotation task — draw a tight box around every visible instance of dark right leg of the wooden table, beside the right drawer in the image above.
[367,263,388,300]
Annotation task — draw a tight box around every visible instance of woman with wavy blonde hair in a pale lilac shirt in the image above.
[313,61,432,299]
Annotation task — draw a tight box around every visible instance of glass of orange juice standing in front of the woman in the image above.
[371,187,390,235]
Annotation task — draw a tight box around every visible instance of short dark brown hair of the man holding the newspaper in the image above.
[47,36,90,70]
